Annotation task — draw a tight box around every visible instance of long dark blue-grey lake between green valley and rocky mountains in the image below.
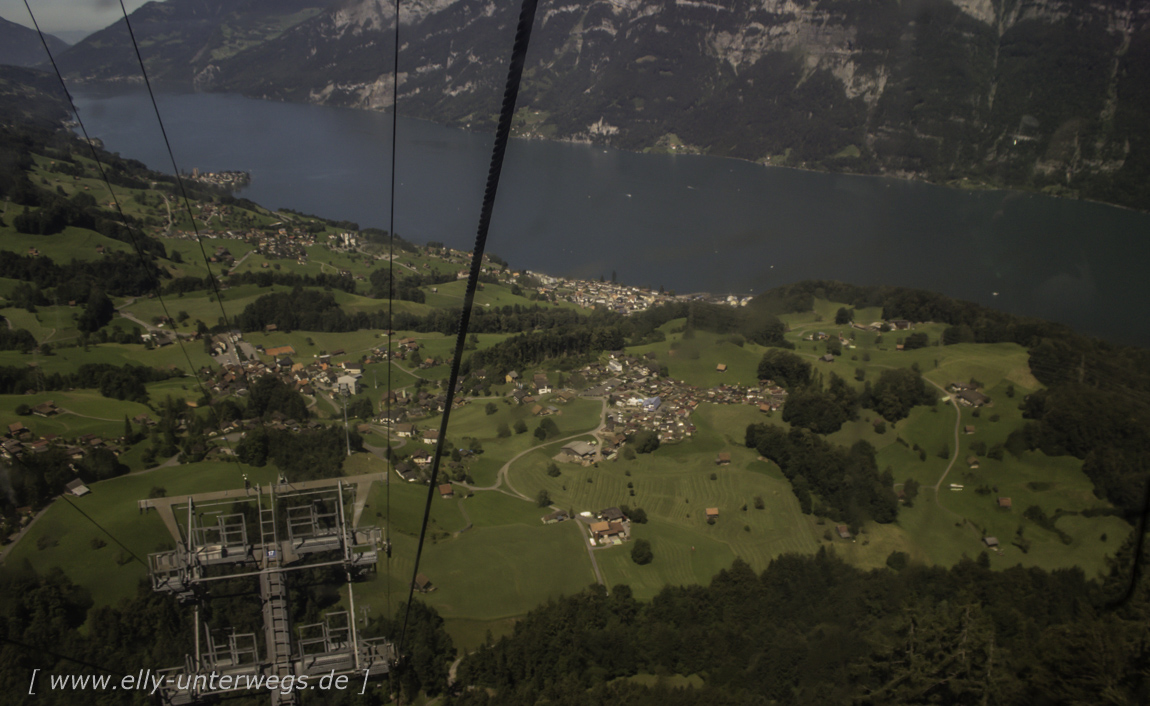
[77,92,1150,344]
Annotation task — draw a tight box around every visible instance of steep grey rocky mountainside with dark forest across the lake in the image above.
[56,0,1150,208]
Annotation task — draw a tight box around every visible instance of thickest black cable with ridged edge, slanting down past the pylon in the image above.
[396,0,538,654]
